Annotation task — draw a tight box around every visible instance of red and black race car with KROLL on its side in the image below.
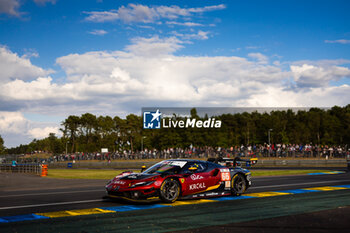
[106,159,251,203]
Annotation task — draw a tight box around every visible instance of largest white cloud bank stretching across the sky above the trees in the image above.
[0,39,349,114]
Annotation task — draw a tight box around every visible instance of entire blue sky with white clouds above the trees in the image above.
[0,0,350,147]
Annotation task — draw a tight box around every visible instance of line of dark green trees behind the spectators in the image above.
[0,104,350,154]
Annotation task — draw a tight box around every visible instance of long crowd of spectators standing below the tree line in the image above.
[49,143,350,162]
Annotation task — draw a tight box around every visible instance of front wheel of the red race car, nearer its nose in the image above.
[159,178,180,203]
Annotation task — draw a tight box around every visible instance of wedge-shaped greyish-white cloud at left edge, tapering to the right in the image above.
[0,47,52,83]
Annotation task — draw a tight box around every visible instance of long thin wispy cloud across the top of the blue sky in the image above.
[84,4,226,23]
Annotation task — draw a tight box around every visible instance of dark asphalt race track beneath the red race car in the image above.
[0,170,350,232]
